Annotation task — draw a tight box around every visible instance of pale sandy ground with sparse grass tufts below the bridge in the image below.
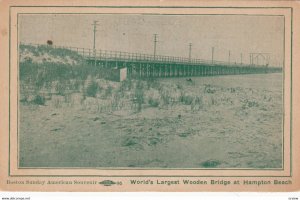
[19,74,282,168]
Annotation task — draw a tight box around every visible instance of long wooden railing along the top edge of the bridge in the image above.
[20,43,272,67]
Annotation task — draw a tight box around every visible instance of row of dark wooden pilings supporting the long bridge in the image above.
[86,60,280,78]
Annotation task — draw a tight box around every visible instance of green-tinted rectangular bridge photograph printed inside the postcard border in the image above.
[17,13,285,170]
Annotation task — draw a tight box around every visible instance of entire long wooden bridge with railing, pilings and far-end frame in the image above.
[22,44,282,78]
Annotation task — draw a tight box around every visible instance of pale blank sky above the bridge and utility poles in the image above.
[18,14,284,66]
